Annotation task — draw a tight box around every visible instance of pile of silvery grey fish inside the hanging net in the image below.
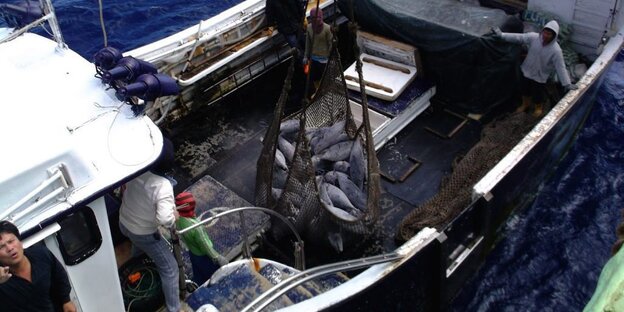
[271,119,367,221]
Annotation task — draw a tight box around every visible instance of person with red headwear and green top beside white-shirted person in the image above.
[176,192,228,285]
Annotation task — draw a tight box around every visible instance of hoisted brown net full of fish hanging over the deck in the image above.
[256,45,380,251]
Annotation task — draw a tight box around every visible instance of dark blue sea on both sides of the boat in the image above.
[19,0,624,311]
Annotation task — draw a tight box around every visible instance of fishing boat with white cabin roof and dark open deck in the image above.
[0,0,624,311]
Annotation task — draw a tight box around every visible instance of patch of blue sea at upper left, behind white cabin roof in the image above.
[53,0,242,60]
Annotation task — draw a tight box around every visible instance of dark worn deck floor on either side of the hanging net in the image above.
[169,63,481,257]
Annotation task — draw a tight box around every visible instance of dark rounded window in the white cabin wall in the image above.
[57,209,102,265]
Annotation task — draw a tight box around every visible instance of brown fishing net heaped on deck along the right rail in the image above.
[396,112,537,241]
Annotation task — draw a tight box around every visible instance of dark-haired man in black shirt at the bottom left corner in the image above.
[0,221,76,312]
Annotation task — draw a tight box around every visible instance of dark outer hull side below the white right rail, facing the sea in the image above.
[316,48,616,311]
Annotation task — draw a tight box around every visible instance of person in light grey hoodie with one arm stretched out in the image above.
[492,20,578,117]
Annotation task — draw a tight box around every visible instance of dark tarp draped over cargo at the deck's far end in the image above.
[338,0,522,114]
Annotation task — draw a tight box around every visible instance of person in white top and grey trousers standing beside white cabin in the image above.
[119,138,188,312]
